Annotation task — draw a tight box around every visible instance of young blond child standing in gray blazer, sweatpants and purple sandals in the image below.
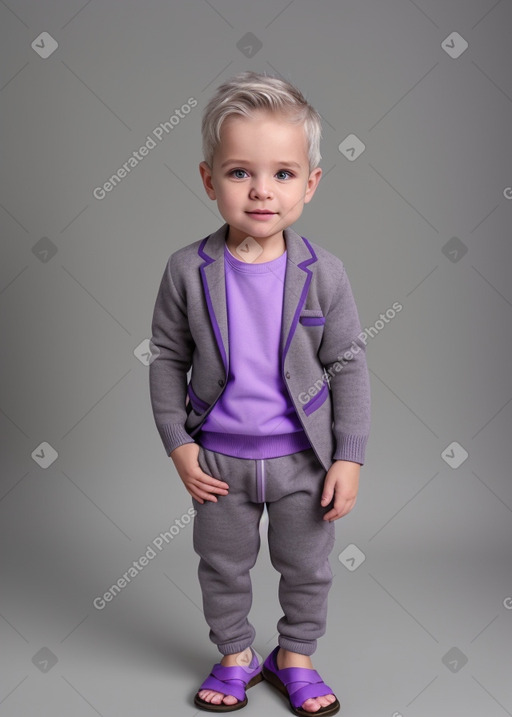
[150,72,370,715]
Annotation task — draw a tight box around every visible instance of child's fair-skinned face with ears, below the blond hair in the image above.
[199,111,322,243]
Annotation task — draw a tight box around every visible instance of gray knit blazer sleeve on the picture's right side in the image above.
[318,264,370,465]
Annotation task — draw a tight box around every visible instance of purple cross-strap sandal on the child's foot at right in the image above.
[263,645,340,717]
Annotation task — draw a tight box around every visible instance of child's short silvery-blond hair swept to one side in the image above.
[201,71,322,172]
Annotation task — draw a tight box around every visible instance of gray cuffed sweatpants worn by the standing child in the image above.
[192,446,335,655]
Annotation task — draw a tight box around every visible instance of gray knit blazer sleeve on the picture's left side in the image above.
[149,256,194,455]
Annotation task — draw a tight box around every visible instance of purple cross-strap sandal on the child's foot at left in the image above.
[194,648,263,712]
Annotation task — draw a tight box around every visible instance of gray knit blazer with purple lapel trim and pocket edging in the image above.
[149,224,370,471]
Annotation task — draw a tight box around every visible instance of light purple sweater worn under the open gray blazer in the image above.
[196,246,311,458]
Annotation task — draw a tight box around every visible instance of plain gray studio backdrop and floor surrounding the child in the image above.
[0,0,512,717]
